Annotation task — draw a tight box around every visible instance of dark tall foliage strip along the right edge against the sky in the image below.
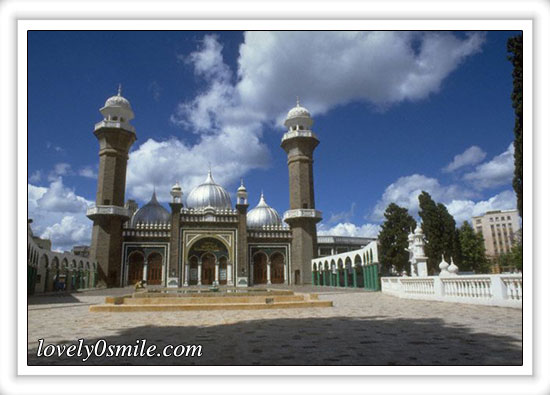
[507,34,523,217]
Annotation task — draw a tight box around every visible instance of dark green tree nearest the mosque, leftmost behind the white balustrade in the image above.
[378,203,416,273]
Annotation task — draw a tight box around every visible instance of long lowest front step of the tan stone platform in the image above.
[90,300,332,312]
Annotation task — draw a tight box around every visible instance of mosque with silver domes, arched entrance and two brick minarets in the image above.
[87,88,373,287]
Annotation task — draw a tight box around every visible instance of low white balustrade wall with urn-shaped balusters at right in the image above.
[380,274,523,308]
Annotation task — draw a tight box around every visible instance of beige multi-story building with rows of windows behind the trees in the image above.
[472,210,521,259]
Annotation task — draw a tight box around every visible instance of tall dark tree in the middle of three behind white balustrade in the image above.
[418,191,460,273]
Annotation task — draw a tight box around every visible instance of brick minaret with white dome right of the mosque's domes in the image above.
[281,100,322,284]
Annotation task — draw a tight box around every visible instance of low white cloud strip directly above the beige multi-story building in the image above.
[446,190,516,226]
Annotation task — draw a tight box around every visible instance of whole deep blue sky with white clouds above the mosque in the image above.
[28,31,517,249]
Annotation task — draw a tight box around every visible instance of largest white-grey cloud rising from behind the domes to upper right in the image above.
[128,32,485,200]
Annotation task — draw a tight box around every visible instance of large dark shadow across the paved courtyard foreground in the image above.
[28,313,522,366]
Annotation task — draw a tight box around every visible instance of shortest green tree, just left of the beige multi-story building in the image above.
[458,221,490,273]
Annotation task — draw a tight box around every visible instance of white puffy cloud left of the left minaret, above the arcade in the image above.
[27,177,93,251]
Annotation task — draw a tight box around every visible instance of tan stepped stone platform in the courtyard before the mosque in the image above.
[90,289,332,312]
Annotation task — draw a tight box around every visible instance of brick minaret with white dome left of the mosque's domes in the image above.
[86,86,136,287]
